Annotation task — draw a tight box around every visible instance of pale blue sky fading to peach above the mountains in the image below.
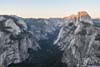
[0,0,100,18]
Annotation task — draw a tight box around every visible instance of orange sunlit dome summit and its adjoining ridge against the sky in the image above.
[65,11,93,26]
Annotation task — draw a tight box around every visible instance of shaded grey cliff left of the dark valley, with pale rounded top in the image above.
[0,15,39,67]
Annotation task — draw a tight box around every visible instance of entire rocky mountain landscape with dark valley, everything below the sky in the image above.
[0,11,100,67]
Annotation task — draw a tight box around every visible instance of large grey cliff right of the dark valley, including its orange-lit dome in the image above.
[55,12,100,67]
